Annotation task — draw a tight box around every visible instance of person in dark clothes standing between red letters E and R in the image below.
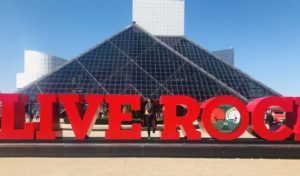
[144,98,156,140]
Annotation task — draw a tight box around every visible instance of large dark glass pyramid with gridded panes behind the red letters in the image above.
[19,24,279,102]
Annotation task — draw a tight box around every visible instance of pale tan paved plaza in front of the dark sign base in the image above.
[0,158,300,176]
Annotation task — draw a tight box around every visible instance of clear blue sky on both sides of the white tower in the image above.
[0,0,300,96]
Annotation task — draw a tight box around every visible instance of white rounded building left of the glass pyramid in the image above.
[17,50,67,89]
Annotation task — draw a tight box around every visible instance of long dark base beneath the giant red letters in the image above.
[0,138,300,159]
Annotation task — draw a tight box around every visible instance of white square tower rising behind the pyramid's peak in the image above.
[132,0,185,36]
